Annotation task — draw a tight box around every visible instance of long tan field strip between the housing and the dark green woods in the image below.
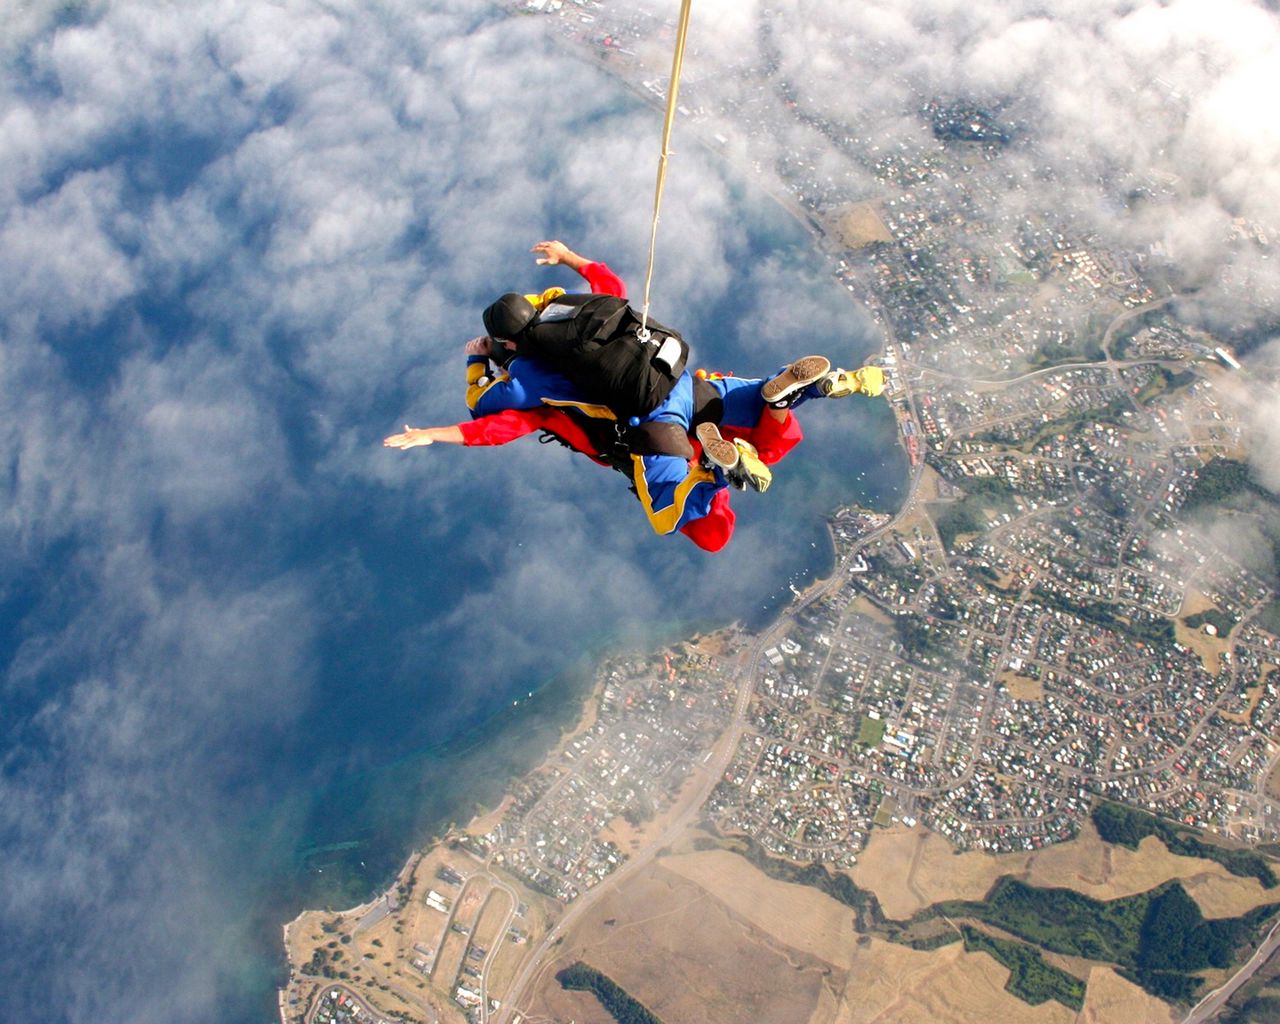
[850,824,1277,919]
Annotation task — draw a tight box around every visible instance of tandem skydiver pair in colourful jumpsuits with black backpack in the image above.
[383,241,884,552]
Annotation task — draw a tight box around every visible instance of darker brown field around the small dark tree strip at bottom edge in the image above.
[527,865,832,1024]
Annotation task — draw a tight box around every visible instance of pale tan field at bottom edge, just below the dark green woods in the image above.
[829,940,1076,1024]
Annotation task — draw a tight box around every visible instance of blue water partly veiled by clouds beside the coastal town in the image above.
[0,14,906,1023]
